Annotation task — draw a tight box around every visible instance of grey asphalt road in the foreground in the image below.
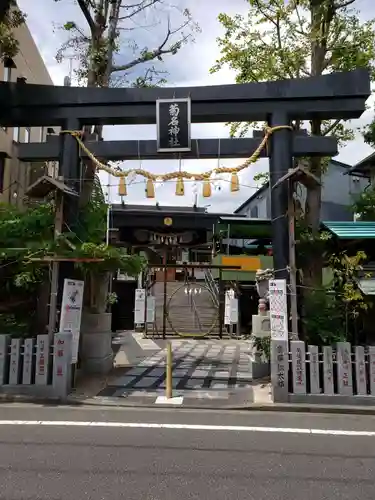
[0,405,375,500]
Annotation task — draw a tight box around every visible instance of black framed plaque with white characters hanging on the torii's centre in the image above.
[156,97,191,153]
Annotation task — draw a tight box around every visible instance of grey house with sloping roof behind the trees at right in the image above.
[234,160,368,221]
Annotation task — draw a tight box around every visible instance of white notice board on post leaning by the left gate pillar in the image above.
[59,279,84,364]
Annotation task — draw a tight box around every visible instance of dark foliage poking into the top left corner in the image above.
[0,0,26,60]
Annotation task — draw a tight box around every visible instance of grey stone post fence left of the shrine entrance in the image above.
[0,333,72,397]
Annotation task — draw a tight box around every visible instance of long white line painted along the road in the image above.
[0,420,375,437]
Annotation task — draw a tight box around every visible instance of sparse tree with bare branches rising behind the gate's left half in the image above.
[55,0,198,206]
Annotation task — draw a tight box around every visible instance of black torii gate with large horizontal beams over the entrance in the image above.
[0,70,370,278]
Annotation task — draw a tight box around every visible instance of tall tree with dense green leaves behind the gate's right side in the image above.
[211,0,375,286]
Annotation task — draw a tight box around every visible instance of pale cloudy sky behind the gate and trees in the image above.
[18,0,375,213]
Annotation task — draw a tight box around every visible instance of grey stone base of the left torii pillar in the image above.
[81,312,114,374]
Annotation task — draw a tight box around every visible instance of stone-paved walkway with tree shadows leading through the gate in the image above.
[95,332,272,403]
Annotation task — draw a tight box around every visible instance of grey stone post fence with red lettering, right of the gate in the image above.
[271,341,375,404]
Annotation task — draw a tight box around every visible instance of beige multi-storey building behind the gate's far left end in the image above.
[0,24,57,207]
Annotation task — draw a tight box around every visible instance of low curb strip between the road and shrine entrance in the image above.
[0,394,375,416]
